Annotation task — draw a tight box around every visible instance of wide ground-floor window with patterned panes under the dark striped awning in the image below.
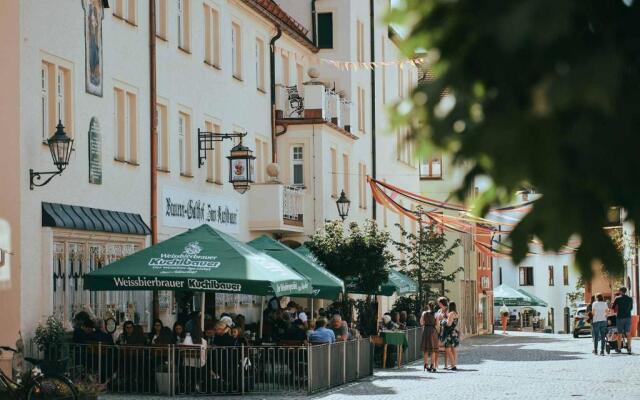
[50,234,151,326]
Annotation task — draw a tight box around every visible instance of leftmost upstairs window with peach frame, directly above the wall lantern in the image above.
[40,61,73,143]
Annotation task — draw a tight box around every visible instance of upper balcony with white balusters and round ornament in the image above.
[276,81,352,132]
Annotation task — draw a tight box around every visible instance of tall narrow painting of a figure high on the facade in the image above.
[81,0,104,97]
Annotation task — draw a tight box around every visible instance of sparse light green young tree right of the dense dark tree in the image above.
[394,219,462,316]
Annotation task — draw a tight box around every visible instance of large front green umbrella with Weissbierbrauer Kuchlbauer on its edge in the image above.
[84,225,311,296]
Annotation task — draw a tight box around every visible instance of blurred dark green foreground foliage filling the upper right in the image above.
[389,0,640,278]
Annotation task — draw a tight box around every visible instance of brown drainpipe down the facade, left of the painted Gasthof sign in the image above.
[149,0,160,319]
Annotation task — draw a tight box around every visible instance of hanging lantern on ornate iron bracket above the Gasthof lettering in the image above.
[198,128,256,194]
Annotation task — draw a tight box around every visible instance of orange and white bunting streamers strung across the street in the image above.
[367,176,579,257]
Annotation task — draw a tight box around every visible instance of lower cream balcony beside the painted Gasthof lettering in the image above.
[249,183,304,233]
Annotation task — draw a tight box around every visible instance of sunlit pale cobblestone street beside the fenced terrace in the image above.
[104,333,640,400]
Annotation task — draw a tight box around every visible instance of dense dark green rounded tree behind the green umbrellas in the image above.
[305,220,393,293]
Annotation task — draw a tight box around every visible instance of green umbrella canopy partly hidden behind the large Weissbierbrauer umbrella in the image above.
[247,235,344,299]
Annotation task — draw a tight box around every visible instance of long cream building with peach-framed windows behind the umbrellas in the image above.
[0,0,418,368]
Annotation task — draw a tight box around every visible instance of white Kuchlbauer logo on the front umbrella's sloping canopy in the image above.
[149,241,220,274]
